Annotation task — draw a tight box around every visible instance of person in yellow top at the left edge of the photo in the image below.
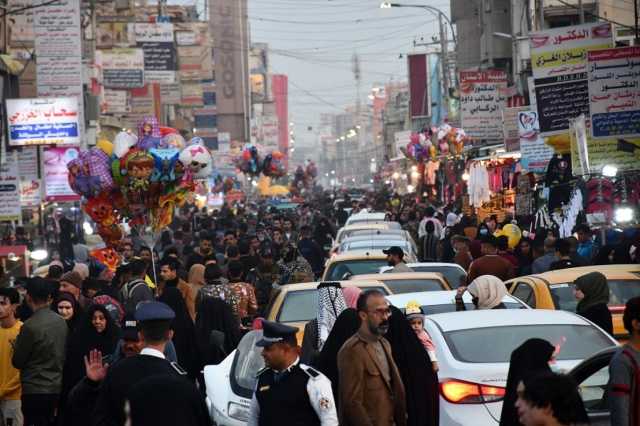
[0,287,24,426]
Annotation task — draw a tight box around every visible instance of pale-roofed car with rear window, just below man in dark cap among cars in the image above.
[348,272,451,294]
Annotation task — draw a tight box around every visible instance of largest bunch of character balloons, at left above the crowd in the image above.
[67,117,212,247]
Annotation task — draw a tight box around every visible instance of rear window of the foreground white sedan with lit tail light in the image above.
[444,324,612,363]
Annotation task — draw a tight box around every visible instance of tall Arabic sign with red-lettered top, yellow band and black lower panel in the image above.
[529,23,613,136]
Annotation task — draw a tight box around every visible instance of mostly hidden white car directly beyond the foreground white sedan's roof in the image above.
[387,290,531,315]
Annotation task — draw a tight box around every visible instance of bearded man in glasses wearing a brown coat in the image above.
[338,290,407,426]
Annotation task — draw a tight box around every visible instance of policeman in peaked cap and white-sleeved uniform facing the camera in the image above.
[248,321,338,426]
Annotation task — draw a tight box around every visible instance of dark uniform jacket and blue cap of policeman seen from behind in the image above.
[91,302,186,426]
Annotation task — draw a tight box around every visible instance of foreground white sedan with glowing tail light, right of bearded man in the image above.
[420,310,617,426]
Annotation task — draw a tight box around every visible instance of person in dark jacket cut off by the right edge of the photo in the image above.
[609,297,640,426]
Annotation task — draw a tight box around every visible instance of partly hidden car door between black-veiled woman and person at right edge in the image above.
[569,349,616,426]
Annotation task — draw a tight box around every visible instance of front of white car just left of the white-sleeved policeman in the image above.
[204,330,264,426]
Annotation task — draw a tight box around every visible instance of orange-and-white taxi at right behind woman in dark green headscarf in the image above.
[505,265,640,339]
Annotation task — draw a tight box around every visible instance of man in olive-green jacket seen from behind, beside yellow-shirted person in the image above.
[11,277,69,426]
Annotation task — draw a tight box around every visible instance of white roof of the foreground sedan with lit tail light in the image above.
[429,309,590,332]
